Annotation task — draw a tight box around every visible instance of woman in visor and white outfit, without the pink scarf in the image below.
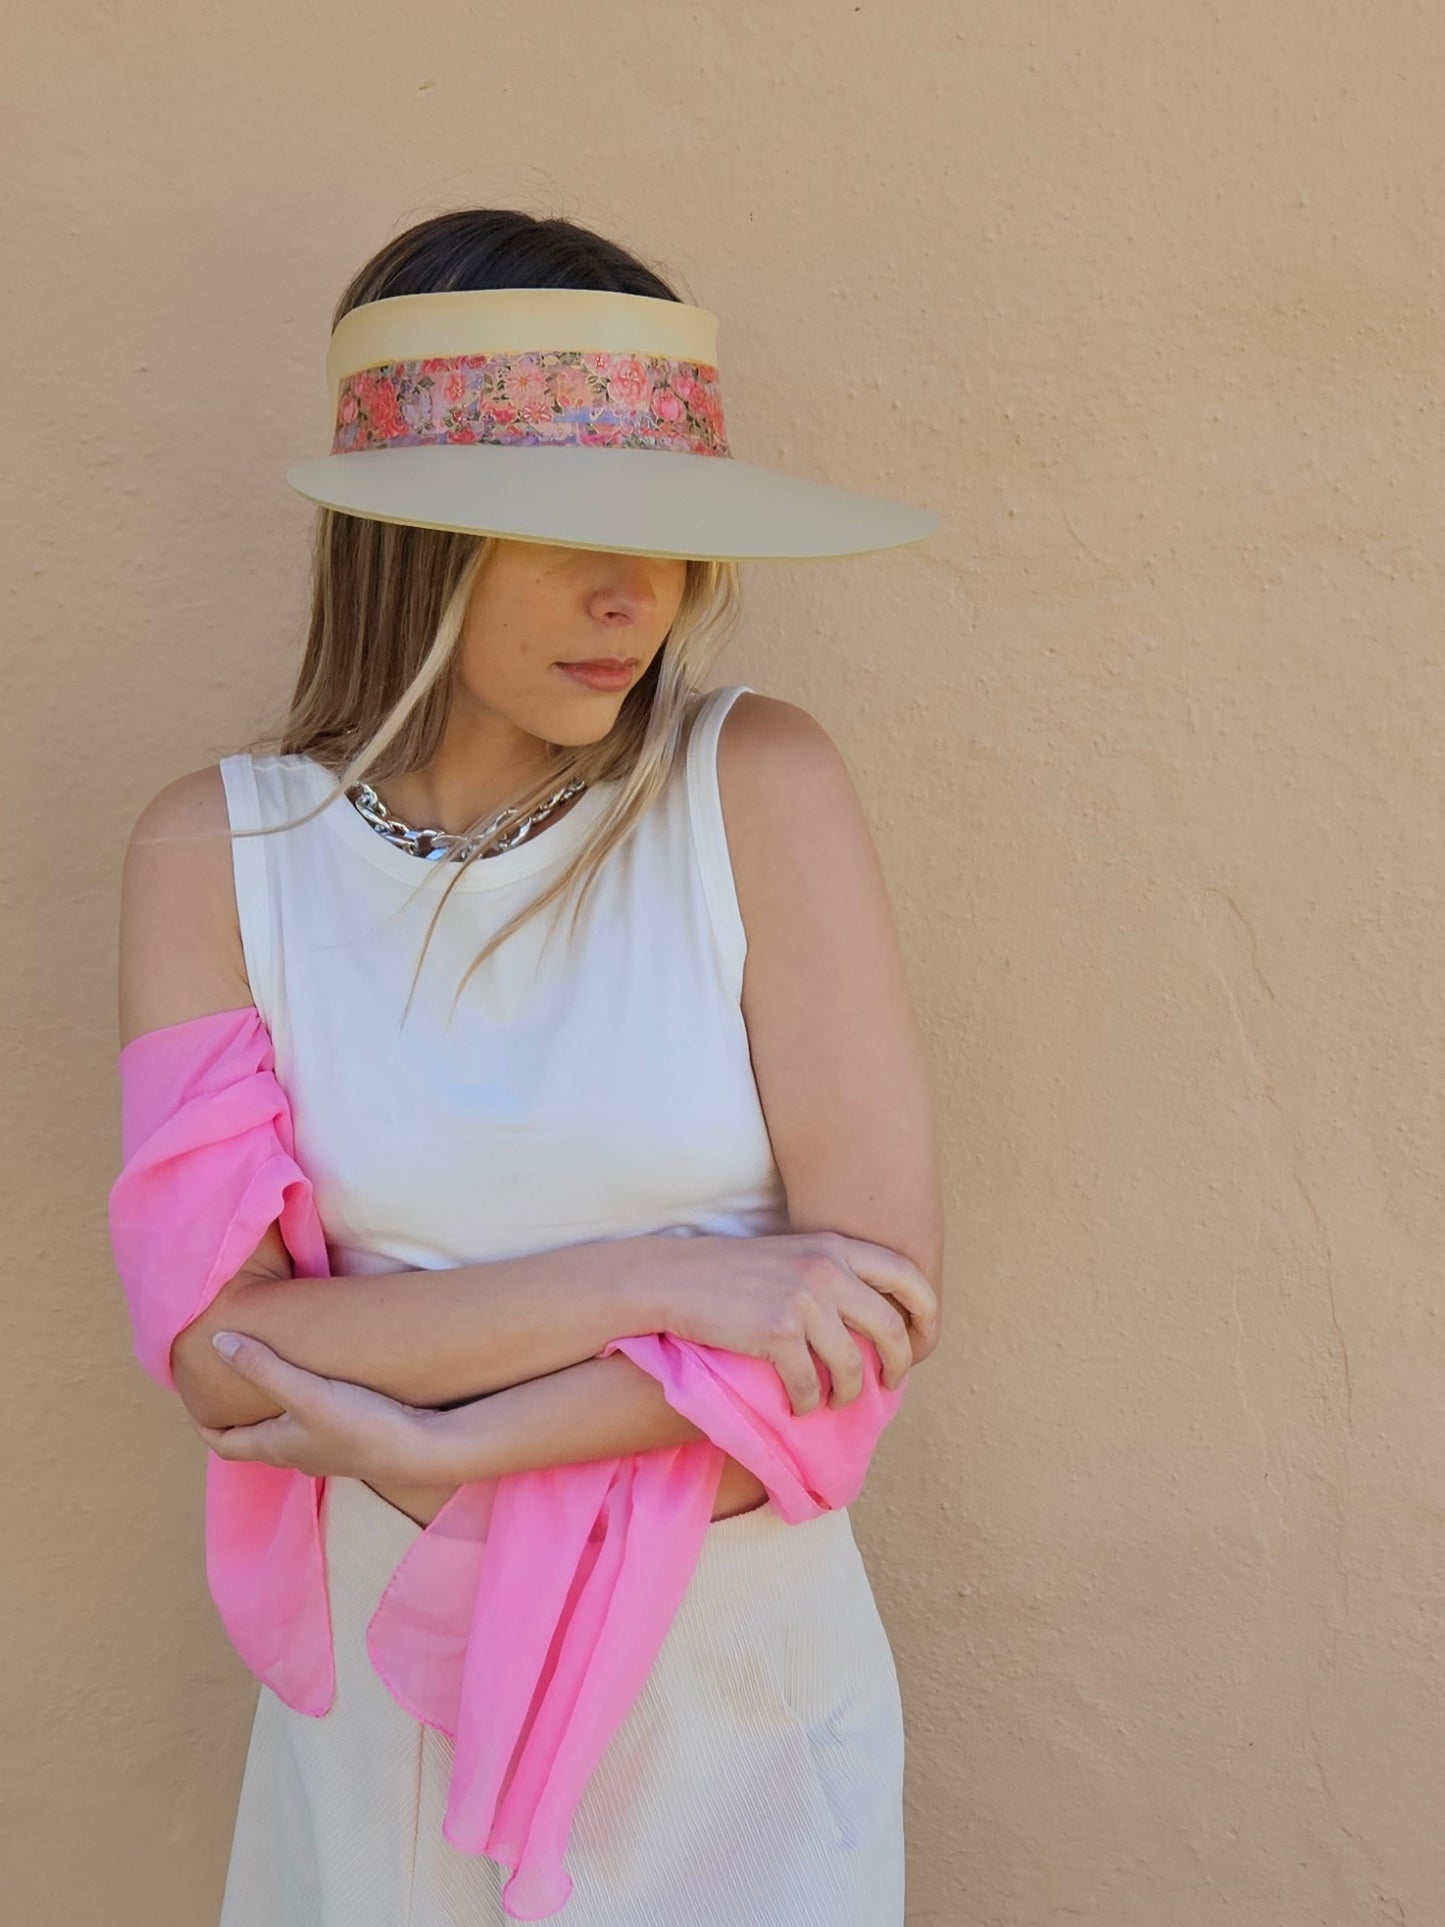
[118,210,942,1927]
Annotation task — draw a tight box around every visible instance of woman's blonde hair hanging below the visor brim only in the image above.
[229,509,742,1021]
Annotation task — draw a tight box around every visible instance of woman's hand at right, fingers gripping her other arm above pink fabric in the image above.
[663,1231,940,1412]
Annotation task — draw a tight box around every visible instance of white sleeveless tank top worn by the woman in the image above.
[220,684,788,1274]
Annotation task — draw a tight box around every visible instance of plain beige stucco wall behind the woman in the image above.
[0,0,1445,1927]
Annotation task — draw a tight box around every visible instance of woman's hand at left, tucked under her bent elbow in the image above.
[191,1332,441,1486]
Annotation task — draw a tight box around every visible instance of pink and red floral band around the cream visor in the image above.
[331,349,730,455]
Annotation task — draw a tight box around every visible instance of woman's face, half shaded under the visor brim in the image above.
[455,540,688,748]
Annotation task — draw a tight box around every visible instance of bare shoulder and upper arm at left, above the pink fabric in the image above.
[119,763,250,1043]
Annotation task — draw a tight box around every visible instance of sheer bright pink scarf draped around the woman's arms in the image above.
[110,1004,906,1919]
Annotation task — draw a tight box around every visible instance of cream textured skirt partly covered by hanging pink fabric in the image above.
[220,1478,904,1927]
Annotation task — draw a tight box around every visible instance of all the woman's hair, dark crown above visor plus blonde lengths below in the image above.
[231,208,742,1021]
